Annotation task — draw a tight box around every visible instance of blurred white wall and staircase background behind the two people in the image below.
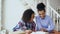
[0,0,60,31]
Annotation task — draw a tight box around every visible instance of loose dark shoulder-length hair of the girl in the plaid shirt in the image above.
[22,9,34,22]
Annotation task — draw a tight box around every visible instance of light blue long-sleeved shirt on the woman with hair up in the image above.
[36,15,54,31]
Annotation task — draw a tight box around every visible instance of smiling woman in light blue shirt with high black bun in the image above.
[36,3,54,32]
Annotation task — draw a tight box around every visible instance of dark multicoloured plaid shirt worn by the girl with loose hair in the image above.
[13,20,36,31]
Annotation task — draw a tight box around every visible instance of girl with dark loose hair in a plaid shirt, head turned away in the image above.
[13,9,36,33]
